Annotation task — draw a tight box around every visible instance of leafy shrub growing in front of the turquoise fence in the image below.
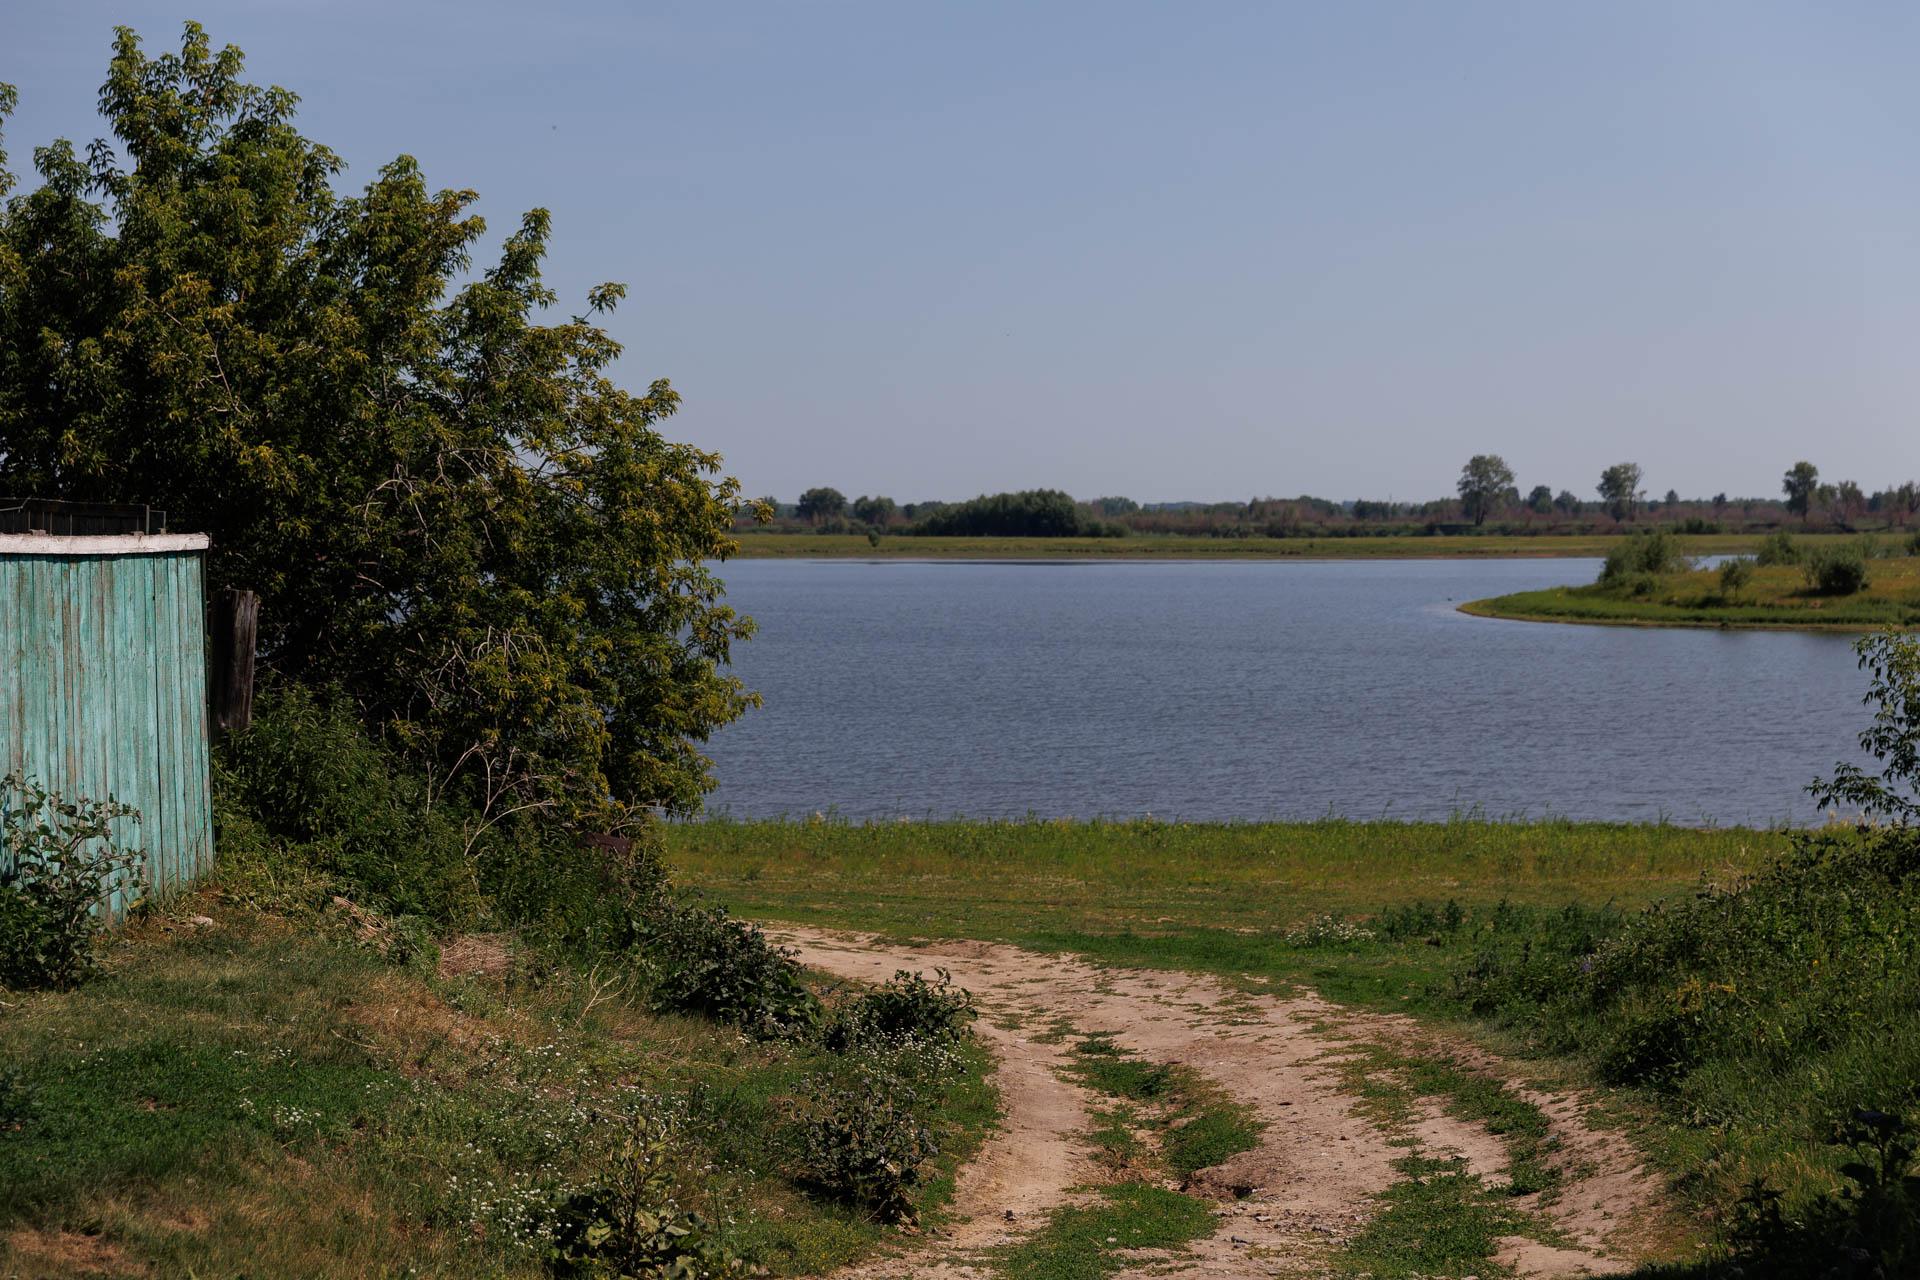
[0,773,142,988]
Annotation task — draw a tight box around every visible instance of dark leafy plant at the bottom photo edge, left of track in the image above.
[541,1119,755,1280]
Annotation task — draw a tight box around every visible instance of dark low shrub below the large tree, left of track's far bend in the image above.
[636,898,820,1040]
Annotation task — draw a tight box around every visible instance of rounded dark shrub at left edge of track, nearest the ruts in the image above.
[799,1067,939,1222]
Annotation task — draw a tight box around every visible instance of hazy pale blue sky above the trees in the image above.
[0,0,1920,501]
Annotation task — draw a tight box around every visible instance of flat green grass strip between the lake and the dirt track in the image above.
[666,819,1786,1007]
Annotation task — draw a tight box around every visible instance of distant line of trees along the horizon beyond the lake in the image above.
[741,453,1920,537]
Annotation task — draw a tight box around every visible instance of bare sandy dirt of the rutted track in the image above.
[768,925,1659,1280]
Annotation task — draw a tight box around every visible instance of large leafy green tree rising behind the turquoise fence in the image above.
[0,23,753,836]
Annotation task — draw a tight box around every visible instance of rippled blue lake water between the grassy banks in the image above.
[708,560,1866,825]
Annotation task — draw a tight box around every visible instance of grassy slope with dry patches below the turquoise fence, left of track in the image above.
[0,898,995,1276]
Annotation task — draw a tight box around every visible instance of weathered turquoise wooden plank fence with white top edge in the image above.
[0,533,213,913]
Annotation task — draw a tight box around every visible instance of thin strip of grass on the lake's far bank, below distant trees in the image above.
[735,532,1845,560]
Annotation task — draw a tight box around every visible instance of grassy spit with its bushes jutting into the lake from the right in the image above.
[1461,530,1920,631]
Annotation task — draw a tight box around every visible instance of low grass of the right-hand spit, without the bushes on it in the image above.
[1461,553,1920,631]
